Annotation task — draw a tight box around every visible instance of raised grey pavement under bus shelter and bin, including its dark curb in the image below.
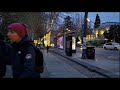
[50,48,120,78]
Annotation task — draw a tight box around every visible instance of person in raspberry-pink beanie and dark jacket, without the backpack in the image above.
[7,23,40,78]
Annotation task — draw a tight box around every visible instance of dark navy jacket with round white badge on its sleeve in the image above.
[11,36,40,78]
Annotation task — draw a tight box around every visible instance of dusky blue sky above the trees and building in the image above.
[58,12,120,27]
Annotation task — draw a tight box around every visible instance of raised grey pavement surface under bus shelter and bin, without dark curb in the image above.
[51,48,120,77]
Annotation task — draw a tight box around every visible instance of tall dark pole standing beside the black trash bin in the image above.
[81,12,88,59]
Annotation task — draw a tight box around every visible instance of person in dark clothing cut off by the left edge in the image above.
[0,33,9,78]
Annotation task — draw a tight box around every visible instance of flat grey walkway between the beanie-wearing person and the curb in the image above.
[41,50,87,78]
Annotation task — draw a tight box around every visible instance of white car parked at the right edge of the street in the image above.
[103,42,120,50]
